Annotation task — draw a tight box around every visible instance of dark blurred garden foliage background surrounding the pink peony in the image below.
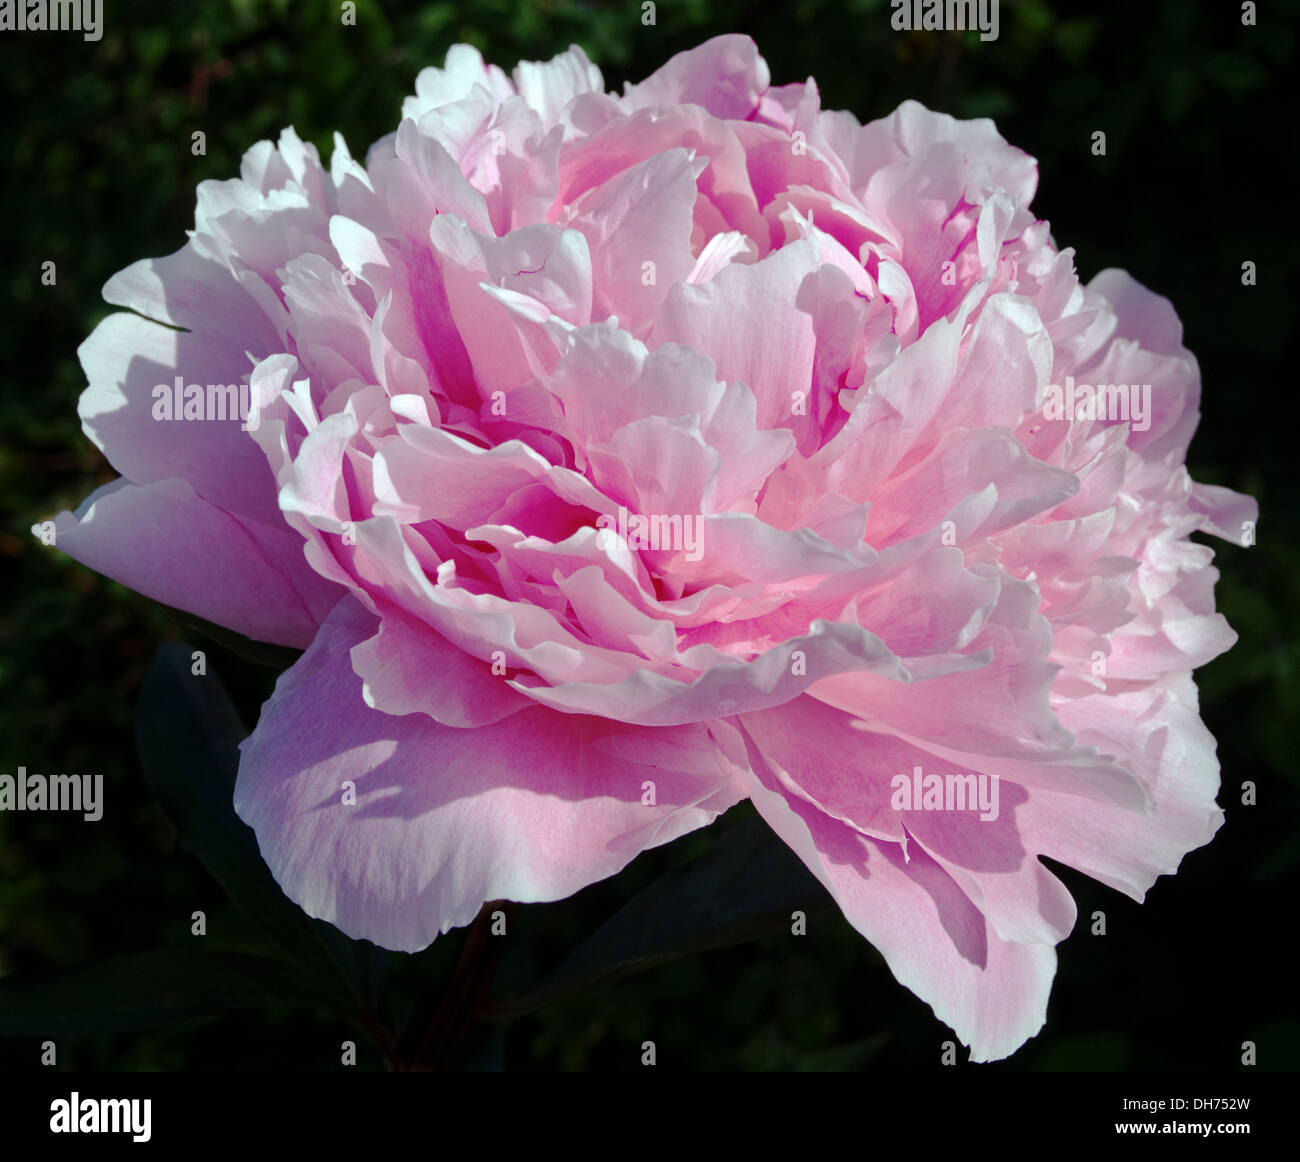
[0,0,1300,1071]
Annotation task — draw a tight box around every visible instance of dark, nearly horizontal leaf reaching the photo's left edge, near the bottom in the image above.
[0,948,330,1037]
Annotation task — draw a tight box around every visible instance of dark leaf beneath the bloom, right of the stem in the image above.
[491,818,832,1016]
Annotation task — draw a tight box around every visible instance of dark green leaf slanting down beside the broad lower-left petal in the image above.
[135,642,356,993]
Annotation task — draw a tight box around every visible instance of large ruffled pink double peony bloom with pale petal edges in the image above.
[45,36,1256,1061]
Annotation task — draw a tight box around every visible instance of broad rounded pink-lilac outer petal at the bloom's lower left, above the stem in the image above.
[235,599,741,951]
